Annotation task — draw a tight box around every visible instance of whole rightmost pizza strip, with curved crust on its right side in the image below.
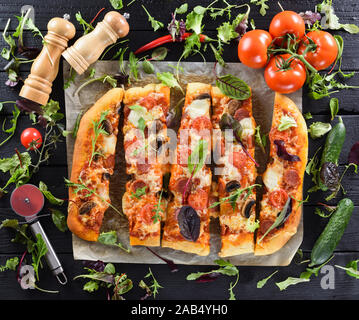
[254,93,308,255]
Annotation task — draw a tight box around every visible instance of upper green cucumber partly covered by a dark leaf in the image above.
[318,117,346,191]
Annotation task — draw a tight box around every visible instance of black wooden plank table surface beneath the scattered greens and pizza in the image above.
[0,0,359,300]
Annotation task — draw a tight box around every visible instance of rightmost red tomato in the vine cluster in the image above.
[298,30,338,70]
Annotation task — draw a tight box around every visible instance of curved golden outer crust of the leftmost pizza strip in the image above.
[67,88,124,241]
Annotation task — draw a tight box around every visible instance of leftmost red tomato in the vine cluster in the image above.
[238,29,272,69]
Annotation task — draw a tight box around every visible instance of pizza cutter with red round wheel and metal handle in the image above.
[10,184,67,285]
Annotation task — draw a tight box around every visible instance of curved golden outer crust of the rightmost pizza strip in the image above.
[254,93,308,255]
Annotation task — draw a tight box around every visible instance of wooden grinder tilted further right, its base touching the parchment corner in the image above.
[62,11,130,74]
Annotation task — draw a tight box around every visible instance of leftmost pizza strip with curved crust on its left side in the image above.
[67,88,124,241]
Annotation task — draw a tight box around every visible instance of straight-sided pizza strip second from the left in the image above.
[122,84,170,246]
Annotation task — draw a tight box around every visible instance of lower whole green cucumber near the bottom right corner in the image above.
[309,198,354,266]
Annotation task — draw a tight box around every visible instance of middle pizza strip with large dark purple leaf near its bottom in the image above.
[162,83,212,256]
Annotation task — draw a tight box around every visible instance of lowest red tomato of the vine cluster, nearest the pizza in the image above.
[264,54,307,93]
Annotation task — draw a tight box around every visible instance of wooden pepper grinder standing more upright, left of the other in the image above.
[20,18,76,105]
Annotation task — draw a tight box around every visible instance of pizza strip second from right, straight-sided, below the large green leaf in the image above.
[212,87,257,257]
